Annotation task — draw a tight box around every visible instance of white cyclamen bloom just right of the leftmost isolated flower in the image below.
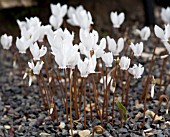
[16,37,31,54]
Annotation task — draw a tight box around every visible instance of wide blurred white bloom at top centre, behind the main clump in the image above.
[67,6,93,31]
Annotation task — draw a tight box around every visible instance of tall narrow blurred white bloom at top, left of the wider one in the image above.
[49,3,67,29]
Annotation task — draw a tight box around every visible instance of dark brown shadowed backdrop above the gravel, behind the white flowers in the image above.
[0,0,170,36]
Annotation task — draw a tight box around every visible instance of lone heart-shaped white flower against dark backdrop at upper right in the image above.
[110,12,125,28]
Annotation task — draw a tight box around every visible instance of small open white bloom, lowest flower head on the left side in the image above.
[28,61,44,75]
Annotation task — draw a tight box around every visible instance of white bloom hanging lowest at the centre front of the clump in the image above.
[77,55,97,77]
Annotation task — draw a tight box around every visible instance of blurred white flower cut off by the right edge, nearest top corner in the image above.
[161,7,170,24]
